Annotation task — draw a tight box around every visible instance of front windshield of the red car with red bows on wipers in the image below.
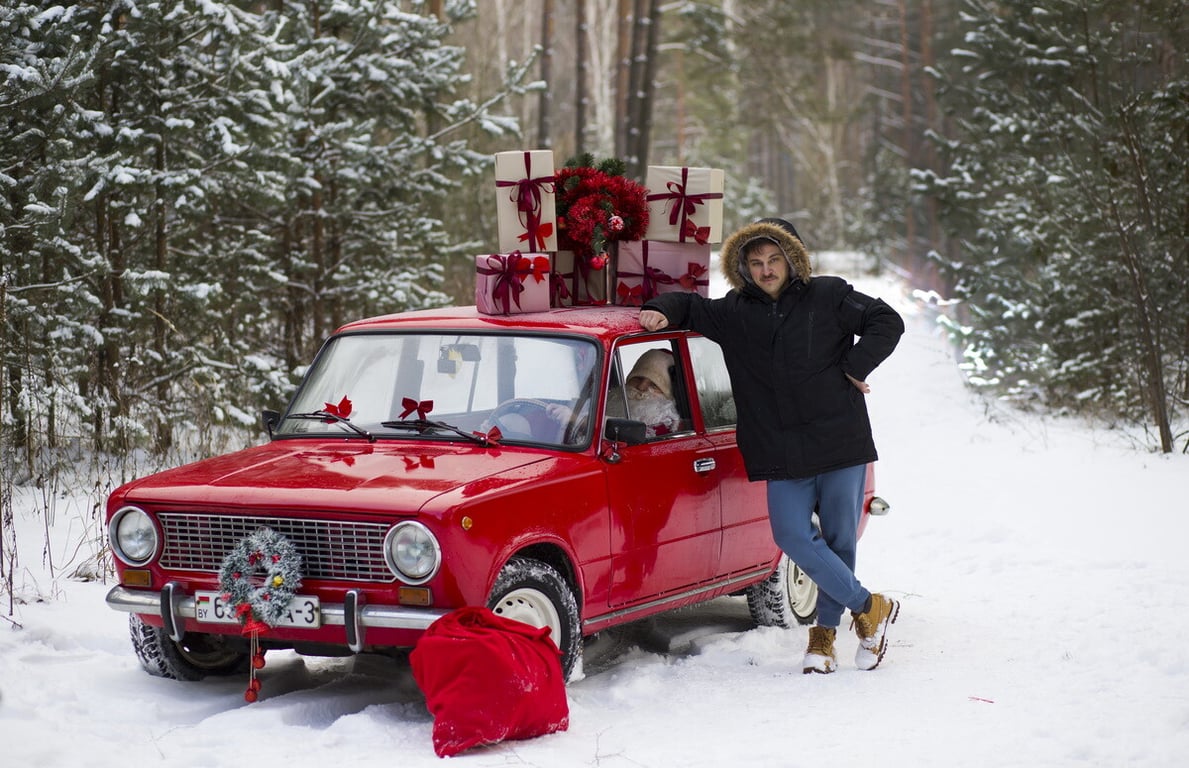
[276,333,598,448]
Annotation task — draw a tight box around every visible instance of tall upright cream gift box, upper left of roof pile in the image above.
[496,150,558,253]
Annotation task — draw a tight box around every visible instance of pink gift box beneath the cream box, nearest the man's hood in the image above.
[615,240,710,307]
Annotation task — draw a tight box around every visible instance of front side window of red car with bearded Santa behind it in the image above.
[605,341,691,440]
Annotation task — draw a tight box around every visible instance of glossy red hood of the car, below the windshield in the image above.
[113,440,564,515]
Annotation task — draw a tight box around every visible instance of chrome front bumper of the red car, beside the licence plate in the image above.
[107,581,448,653]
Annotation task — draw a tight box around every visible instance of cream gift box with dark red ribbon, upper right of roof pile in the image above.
[643,165,725,245]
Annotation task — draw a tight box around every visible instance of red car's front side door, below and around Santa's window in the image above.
[603,339,722,606]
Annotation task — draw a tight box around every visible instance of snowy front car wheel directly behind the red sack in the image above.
[487,558,583,680]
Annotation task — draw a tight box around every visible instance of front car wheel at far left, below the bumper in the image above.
[128,613,247,680]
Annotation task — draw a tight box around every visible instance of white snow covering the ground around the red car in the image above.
[0,260,1189,768]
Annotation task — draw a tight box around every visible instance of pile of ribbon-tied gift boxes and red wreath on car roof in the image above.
[474,150,723,315]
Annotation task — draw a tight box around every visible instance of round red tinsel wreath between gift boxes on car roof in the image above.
[554,155,648,270]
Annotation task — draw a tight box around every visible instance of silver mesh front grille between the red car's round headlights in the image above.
[159,512,396,583]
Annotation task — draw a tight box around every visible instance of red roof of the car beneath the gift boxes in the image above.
[338,304,643,338]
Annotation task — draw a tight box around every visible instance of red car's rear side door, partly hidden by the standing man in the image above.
[686,336,778,574]
